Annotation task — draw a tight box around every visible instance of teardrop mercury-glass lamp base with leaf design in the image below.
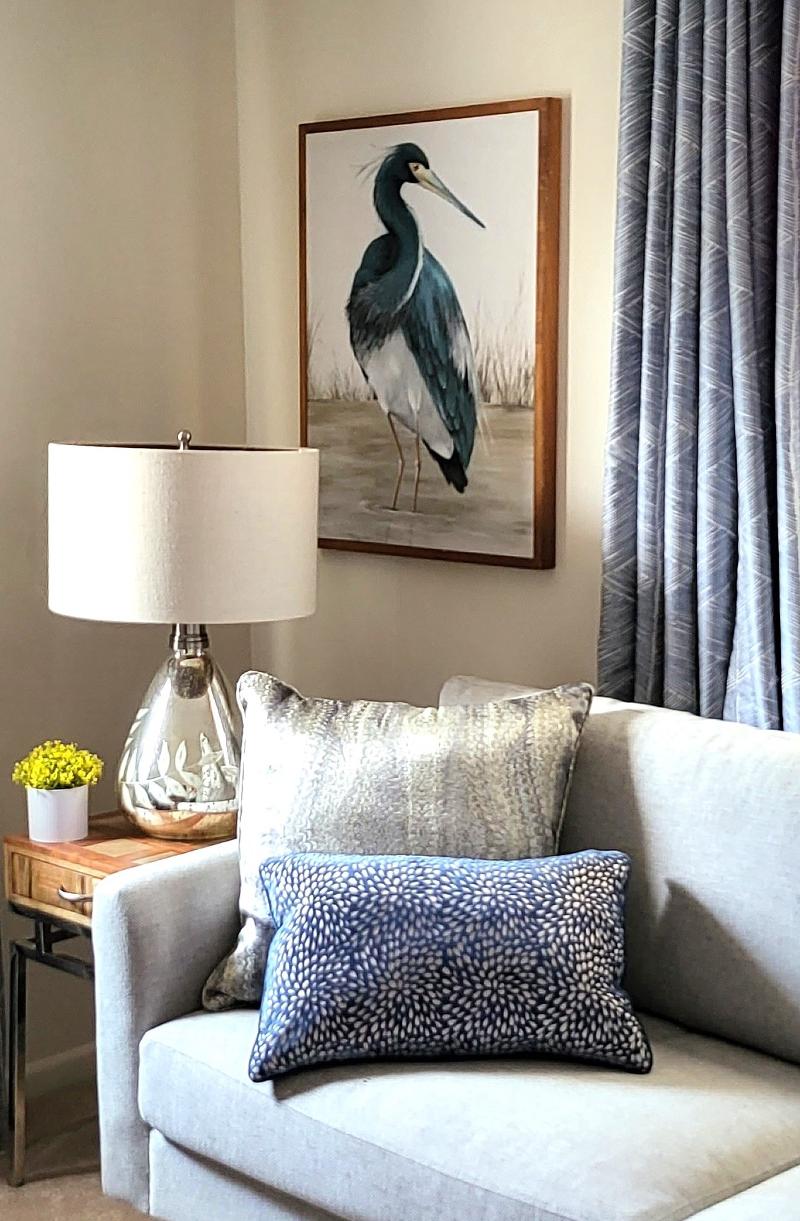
[117,624,242,840]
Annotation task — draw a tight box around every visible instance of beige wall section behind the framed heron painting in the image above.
[237,0,622,701]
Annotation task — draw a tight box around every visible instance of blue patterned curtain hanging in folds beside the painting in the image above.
[598,0,800,731]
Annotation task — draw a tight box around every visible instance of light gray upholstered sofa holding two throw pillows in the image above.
[94,686,800,1221]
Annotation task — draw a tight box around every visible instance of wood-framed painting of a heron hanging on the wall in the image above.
[299,98,561,568]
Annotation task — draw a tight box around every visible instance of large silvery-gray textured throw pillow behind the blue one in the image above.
[203,673,592,1009]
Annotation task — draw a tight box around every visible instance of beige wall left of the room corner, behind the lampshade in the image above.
[0,0,249,1057]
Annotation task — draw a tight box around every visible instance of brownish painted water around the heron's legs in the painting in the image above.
[308,399,534,557]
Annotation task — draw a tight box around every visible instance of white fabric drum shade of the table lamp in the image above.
[49,444,319,624]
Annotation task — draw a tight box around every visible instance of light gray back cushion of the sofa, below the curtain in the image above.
[442,679,800,1062]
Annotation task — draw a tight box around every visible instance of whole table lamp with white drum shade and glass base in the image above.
[48,432,319,840]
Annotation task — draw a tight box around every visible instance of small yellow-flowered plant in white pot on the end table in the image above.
[11,739,103,844]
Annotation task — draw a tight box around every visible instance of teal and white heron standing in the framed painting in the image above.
[347,144,485,513]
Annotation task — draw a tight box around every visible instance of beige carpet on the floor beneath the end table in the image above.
[0,1085,142,1221]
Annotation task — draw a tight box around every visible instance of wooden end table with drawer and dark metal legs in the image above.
[0,813,228,1187]
